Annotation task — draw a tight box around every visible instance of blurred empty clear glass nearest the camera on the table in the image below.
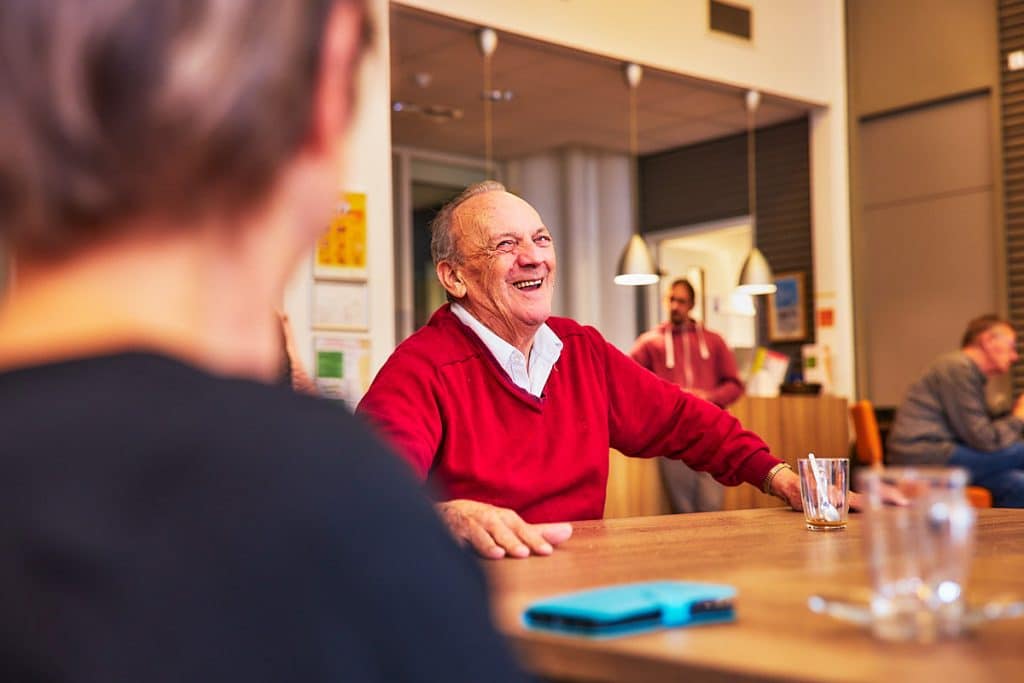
[858,467,976,642]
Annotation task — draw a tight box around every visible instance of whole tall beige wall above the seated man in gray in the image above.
[847,0,1005,404]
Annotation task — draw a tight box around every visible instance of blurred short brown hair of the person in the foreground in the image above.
[0,0,366,255]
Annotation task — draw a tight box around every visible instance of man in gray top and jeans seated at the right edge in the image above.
[888,315,1024,508]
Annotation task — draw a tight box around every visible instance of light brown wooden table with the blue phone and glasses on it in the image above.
[484,509,1024,683]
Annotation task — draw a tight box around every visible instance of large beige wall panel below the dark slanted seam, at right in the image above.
[860,95,996,405]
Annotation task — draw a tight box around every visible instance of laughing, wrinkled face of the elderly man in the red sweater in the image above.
[454,191,555,344]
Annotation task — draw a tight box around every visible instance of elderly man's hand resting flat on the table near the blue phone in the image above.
[436,497,573,560]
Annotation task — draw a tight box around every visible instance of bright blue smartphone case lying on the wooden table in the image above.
[523,581,736,636]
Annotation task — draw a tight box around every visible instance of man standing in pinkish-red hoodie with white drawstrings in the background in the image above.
[630,278,743,512]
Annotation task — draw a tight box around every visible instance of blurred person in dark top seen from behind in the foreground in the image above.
[0,0,520,683]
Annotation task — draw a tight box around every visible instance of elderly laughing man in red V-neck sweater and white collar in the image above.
[358,181,800,559]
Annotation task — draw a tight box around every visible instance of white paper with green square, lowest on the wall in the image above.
[313,334,370,411]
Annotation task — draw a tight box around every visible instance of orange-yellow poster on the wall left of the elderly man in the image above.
[313,193,367,280]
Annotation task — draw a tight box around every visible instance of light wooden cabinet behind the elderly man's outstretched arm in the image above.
[604,395,850,518]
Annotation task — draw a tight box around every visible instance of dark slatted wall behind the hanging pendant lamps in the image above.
[639,118,814,359]
